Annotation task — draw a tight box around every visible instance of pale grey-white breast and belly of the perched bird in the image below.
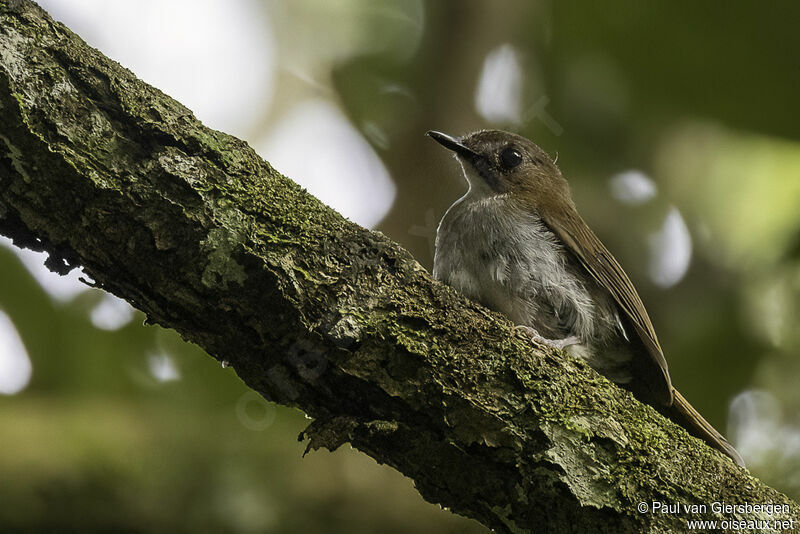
[433,196,624,381]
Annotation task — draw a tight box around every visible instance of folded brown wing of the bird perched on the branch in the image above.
[543,212,673,406]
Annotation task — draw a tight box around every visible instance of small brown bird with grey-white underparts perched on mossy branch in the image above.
[428,130,744,466]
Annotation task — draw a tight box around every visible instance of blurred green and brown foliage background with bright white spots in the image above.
[0,0,800,533]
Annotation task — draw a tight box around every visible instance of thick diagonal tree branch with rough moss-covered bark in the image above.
[0,0,800,533]
